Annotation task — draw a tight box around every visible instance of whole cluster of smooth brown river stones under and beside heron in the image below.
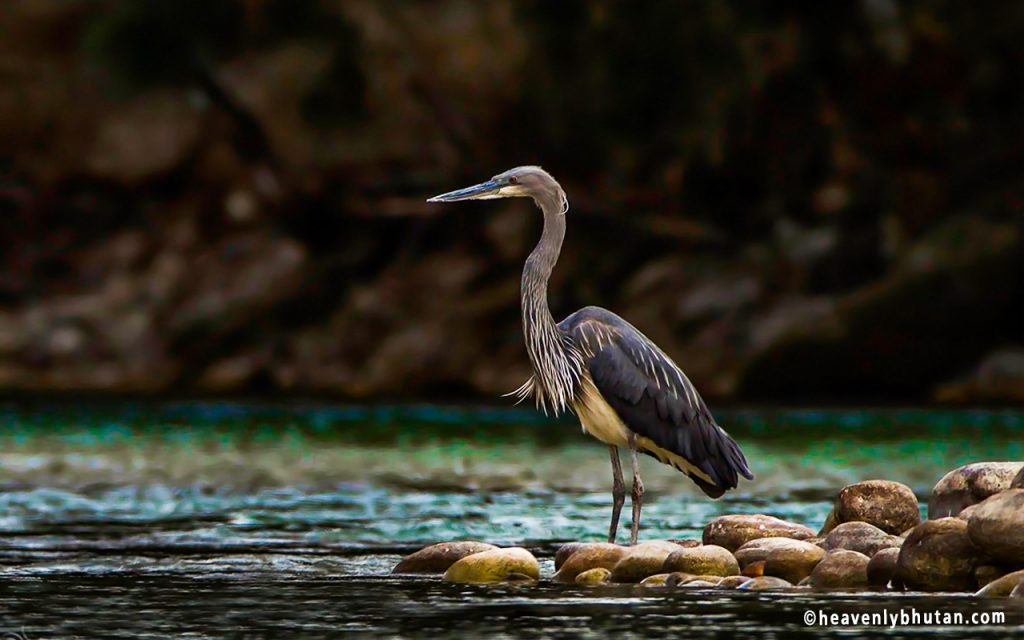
[393,462,1024,597]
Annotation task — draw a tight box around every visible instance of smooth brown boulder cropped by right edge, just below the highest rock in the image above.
[967,488,1024,566]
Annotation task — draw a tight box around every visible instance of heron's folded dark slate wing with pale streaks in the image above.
[559,307,754,498]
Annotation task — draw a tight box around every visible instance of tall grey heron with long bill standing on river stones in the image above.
[427,166,754,545]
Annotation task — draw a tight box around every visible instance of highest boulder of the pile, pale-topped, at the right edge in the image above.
[928,462,1024,520]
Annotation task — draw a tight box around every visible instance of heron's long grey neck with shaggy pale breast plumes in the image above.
[515,187,583,415]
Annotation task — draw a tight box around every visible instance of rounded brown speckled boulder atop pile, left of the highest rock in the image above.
[824,480,921,536]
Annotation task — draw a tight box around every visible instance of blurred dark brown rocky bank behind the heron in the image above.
[0,0,1024,403]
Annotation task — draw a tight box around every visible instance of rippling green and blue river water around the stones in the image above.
[0,403,1024,638]
